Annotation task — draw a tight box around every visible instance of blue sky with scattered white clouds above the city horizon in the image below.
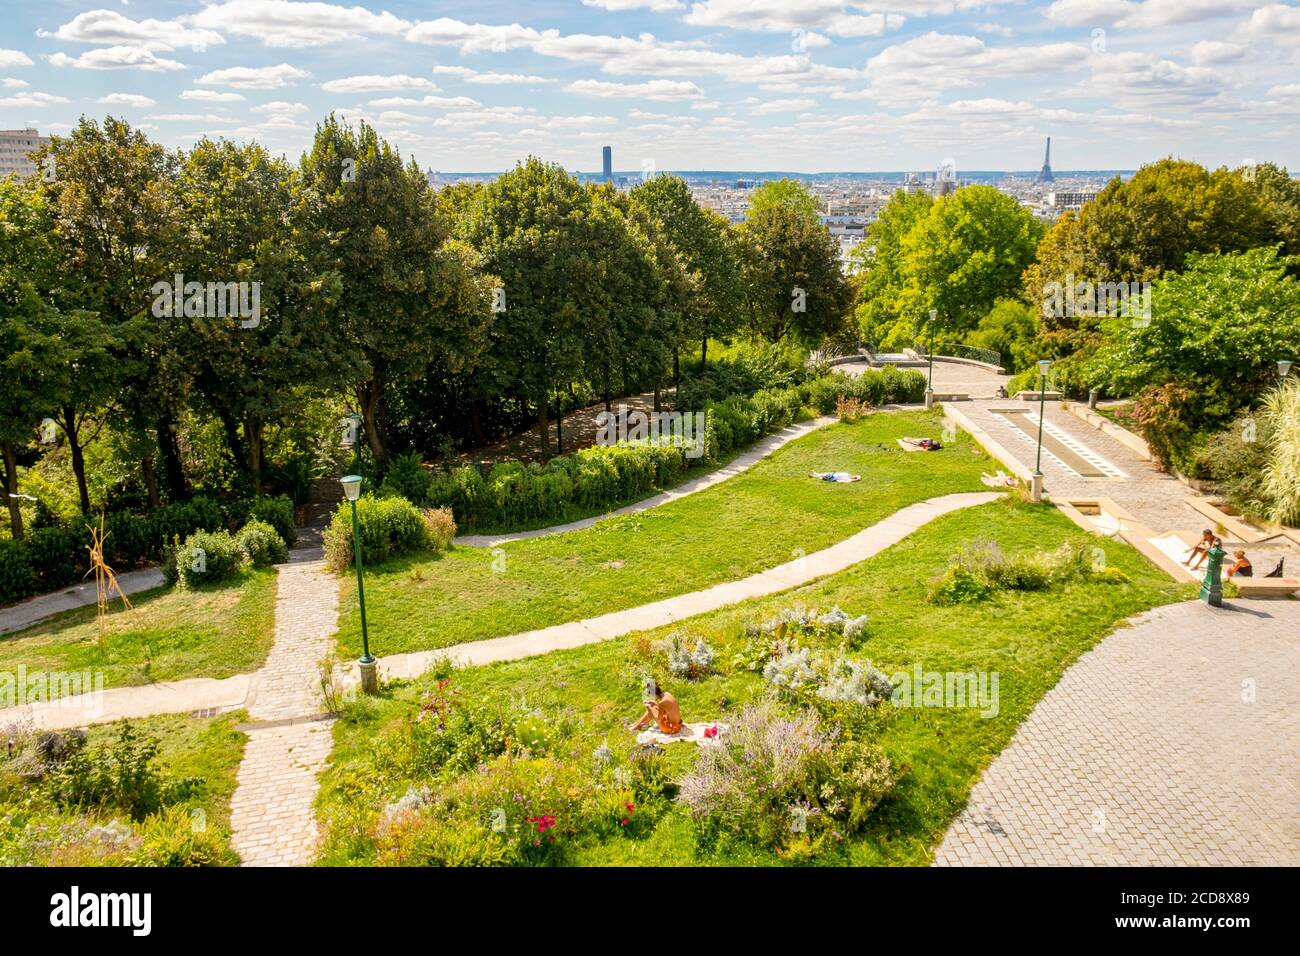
[0,0,1300,173]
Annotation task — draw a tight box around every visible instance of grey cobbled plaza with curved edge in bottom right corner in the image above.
[935,600,1300,866]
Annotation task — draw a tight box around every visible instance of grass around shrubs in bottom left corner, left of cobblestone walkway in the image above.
[0,710,247,866]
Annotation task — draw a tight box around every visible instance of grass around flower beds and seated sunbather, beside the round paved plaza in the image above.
[319,501,1191,866]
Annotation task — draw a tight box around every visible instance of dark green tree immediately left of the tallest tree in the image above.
[169,139,364,494]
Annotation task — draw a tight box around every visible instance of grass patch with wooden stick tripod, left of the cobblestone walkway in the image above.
[0,570,276,687]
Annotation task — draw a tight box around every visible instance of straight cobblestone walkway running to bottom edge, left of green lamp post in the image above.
[230,551,338,866]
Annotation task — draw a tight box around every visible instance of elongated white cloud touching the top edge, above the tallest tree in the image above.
[182,0,411,48]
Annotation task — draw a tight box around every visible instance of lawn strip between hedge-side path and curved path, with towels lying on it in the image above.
[339,412,989,656]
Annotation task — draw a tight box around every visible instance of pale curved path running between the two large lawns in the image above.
[371,492,1001,679]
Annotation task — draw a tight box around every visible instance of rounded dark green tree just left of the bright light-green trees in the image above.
[740,204,852,345]
